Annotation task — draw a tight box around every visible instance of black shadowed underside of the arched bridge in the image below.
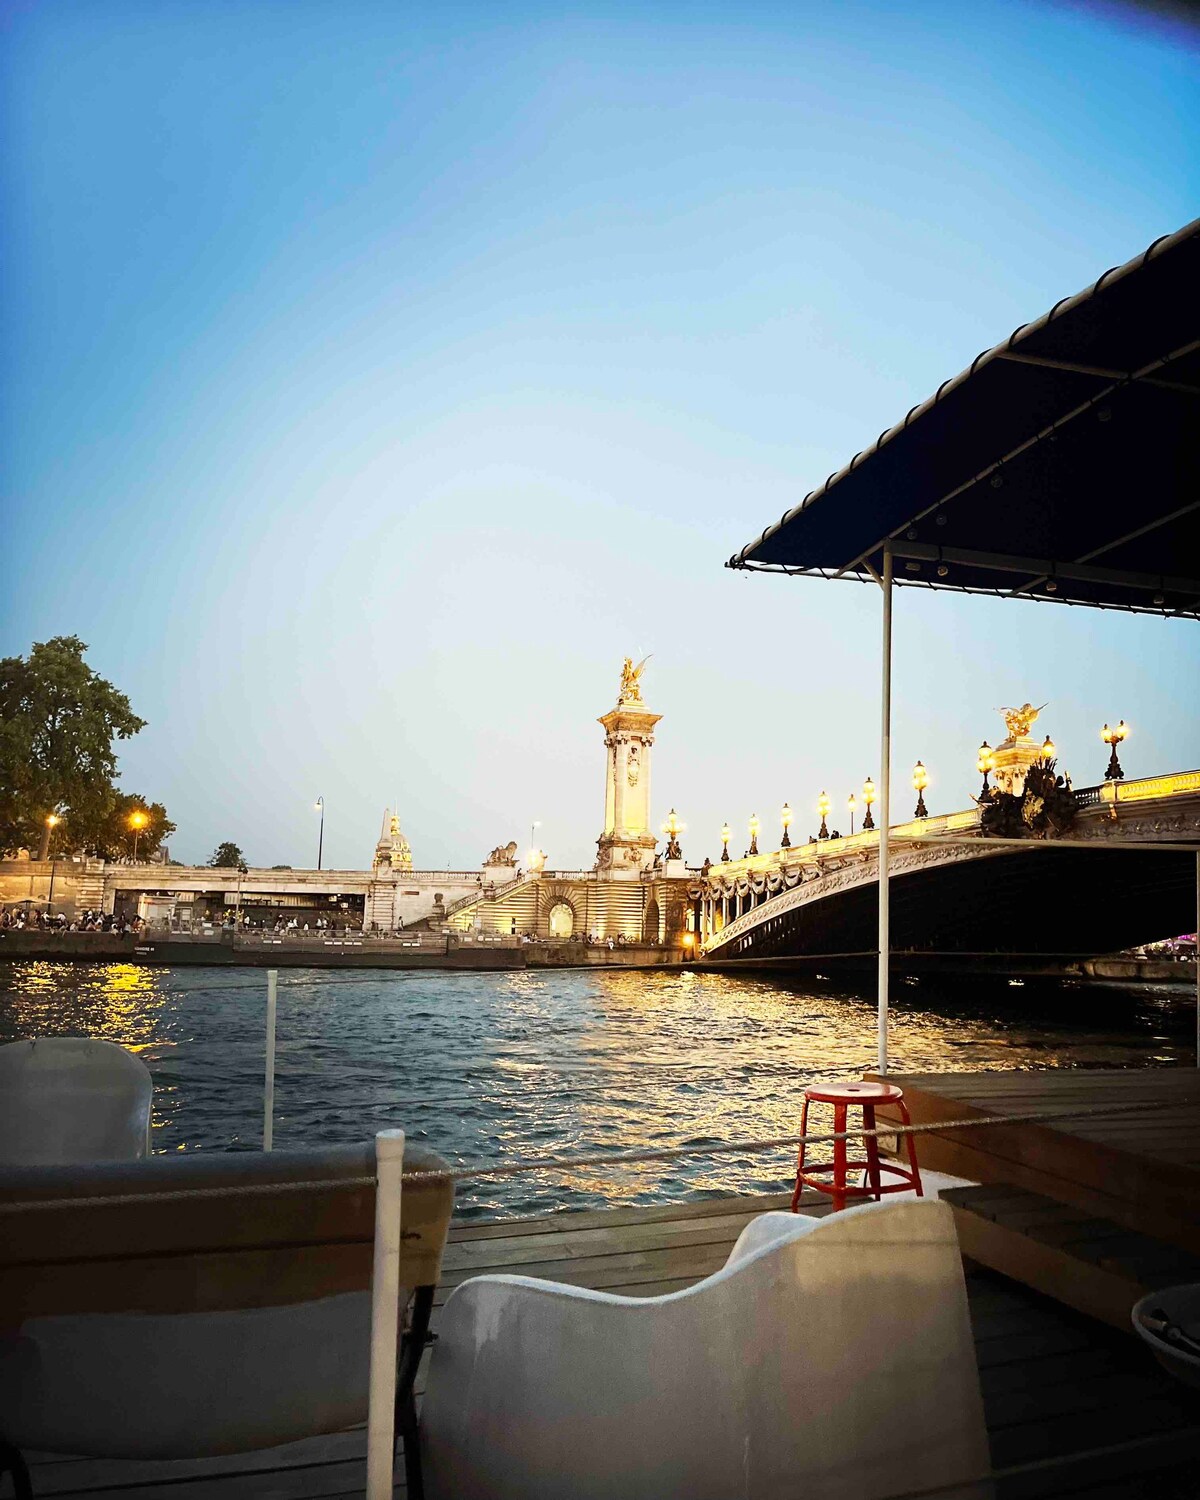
[713,846,1196,969]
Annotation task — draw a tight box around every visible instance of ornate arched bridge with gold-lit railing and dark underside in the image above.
[690,771,1200,972]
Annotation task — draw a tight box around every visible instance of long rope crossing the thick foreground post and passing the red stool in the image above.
[0,1097,1200,1214]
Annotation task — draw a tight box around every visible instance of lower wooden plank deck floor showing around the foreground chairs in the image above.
[18,1196,1200,1500]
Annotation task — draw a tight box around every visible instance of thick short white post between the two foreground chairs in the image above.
[366,1130,404,1500]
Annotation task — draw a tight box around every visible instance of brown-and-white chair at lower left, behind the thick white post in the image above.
[0,1146,455,1496]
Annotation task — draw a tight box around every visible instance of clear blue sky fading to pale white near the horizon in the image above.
[0,0,1200,869]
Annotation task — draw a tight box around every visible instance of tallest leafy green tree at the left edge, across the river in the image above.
[0,636,146,858]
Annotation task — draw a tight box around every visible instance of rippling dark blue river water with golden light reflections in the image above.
[0,962,1196,1217]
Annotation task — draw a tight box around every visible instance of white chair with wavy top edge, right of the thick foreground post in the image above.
[422,1200,992,1500]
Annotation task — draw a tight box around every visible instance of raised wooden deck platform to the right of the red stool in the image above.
[881,1068,1200,1256]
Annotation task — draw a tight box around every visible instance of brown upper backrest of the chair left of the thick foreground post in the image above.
[0,1143,455,1325]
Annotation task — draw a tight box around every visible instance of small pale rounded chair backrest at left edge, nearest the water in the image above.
[0,1037,153,1166]
